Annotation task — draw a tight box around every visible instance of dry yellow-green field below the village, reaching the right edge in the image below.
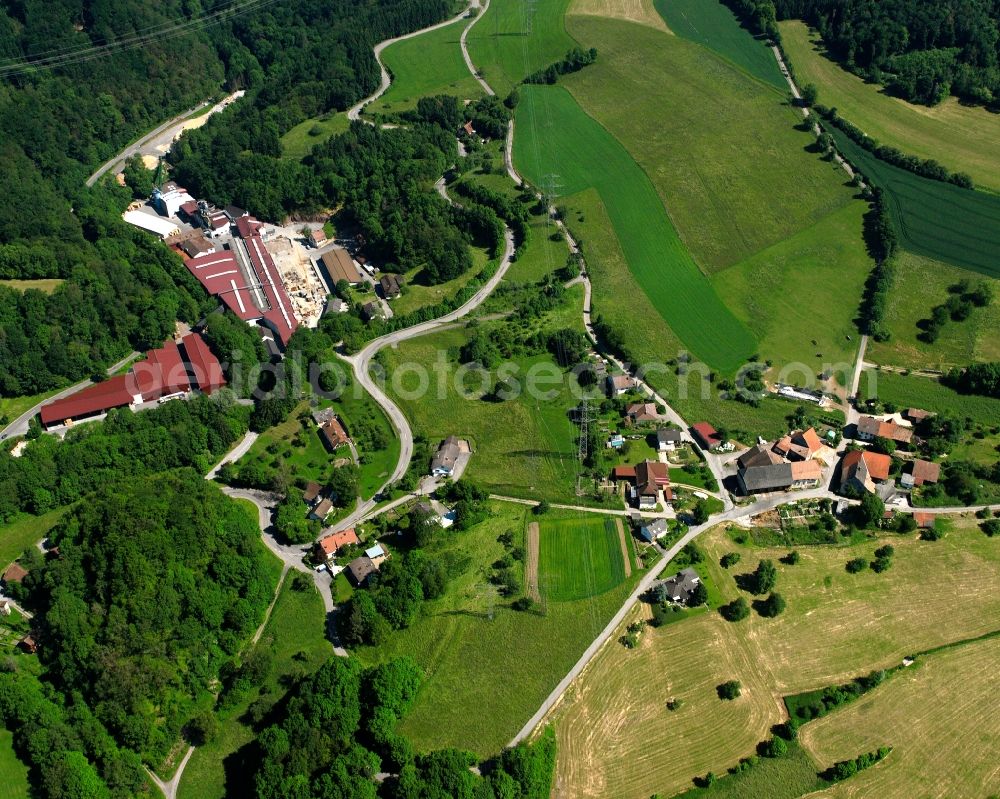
[701,515,1000,694]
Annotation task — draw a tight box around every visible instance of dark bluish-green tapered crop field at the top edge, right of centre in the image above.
[654,0,788,92]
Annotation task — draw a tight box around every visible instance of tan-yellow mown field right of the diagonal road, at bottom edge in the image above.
[552,605,784,799]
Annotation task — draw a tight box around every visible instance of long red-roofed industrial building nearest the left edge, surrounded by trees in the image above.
[39,333,226,428]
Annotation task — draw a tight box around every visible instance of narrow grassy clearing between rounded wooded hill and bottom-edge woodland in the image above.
[174,572,333,799]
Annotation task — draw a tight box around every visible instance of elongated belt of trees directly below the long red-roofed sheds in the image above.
[0,396,247,522]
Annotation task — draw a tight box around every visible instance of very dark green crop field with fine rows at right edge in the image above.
[830,126,1000,277]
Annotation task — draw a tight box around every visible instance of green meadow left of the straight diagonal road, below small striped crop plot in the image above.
[360,503,638,756]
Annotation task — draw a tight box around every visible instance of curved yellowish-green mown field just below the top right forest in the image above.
[779,20,1000,191]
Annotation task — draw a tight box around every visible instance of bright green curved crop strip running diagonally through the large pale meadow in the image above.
[514,83,754,369]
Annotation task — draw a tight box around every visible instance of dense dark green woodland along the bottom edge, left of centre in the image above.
[255,658,555,799]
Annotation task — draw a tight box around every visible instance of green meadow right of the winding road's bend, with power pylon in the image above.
[378,322,579,502]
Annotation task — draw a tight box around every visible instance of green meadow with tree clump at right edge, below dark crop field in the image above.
[865,250,1000,371]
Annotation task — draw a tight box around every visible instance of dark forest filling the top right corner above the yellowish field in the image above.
[725,0,1000,107]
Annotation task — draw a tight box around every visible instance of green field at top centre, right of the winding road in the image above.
[466,0,577,97]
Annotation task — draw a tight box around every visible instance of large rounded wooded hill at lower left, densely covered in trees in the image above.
[6,470,274,780]
